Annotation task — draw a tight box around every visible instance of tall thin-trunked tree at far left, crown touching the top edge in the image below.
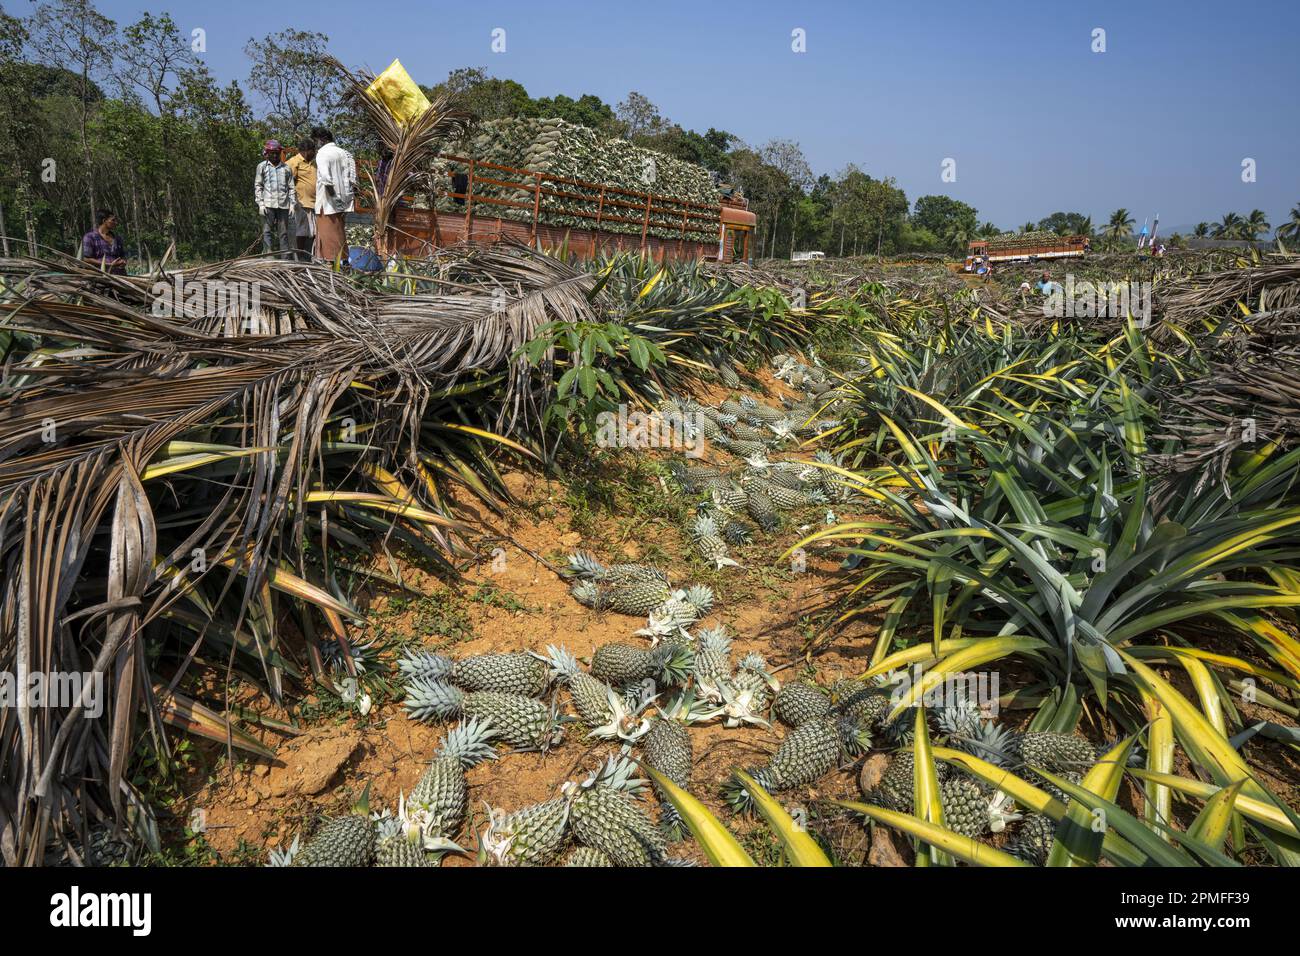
[27,0,117,225]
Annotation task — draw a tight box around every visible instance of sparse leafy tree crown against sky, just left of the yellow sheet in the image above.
[244,30,343,139]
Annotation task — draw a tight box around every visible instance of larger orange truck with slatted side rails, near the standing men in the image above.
[356,153,758,263]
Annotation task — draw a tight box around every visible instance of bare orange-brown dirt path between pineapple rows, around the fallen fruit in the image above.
[185,364,894,866]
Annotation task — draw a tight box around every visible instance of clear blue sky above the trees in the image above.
[5,0,1300,232]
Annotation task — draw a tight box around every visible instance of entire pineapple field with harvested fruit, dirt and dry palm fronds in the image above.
[0,55,1300,866]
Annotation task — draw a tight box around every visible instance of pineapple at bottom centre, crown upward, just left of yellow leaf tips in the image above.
[566,757,668,866]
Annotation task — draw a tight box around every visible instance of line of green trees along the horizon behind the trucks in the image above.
[0,0,1300,260]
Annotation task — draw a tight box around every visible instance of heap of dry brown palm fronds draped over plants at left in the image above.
[0,246,595,865]
